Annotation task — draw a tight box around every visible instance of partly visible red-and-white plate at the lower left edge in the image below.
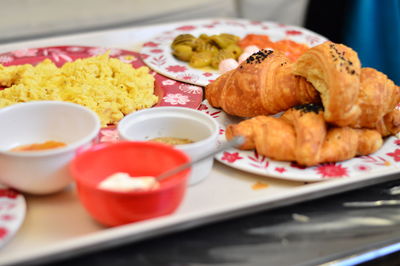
[0,185,26,248]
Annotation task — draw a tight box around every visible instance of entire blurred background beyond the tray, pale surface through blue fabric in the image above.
[0,0,400,84]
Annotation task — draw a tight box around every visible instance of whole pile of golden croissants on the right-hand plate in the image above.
[205,41,400,166]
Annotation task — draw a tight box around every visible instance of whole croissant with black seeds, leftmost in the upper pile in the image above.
[205,50,320,117]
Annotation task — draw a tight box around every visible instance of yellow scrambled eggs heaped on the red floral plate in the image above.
[0,54,158,126]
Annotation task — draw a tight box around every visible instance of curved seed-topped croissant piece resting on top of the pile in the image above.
[293,41,361,126]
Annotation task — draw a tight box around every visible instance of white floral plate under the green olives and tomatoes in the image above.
[141,20,326,86]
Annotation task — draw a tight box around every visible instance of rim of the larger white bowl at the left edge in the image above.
[0,101,101,157]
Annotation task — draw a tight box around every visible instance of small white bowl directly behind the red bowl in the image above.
[117,106,219,185]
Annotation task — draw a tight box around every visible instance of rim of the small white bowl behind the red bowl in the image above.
[117,106,219,148]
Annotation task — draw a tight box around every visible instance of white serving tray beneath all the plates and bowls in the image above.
[0,18,399,265]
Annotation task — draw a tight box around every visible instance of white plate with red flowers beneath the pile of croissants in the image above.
[199,101,400,182]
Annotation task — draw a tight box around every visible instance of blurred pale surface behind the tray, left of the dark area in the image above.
[0,0,308,43]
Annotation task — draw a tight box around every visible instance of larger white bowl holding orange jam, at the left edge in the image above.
[0,101,100,194]
